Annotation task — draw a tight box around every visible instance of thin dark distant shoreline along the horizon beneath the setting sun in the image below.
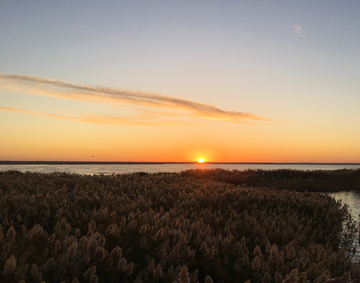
[0,161,360,165]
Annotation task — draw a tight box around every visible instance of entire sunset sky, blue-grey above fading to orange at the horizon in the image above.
[0,0,360,163]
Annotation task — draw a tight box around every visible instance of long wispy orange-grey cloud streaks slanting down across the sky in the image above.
[0,74,272,124]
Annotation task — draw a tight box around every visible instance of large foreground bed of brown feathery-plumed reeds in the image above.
[0,171,360,283]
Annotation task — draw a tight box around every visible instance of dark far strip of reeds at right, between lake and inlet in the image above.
[181,168,360,192]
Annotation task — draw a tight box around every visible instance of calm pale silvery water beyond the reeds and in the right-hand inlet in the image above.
[0,164,360,258]
